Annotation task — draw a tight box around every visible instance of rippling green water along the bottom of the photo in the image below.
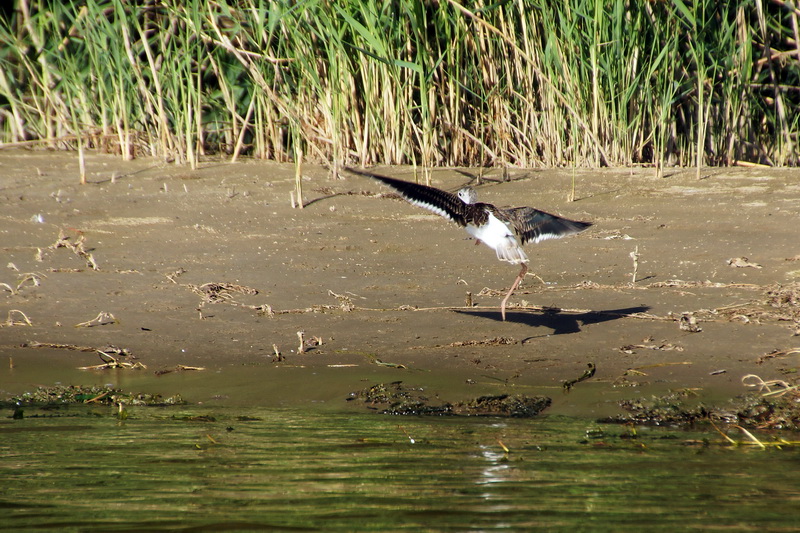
[0,407,800,531]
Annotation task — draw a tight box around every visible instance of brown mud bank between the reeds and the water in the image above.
[0,150,800,417]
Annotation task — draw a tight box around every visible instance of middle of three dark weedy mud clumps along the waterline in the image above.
[347,381,550,418]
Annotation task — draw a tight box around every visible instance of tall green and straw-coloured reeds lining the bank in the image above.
[0,0,800,168]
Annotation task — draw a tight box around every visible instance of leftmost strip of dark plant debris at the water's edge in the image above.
[0,385,186,410]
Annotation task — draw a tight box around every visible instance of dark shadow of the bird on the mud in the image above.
[455,305,650,335]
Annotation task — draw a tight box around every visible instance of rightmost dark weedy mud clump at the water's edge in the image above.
[602,384,800,431]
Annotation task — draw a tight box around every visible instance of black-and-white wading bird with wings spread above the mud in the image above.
[347,168,592,321]
